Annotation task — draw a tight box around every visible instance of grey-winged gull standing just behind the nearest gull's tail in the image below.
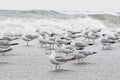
[72,50,97,63]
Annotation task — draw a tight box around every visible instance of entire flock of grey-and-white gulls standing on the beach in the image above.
[0,28,120,70]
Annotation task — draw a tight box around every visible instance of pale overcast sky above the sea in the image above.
[0,0,120,11]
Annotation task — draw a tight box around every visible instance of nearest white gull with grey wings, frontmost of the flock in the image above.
[46,51,74,70]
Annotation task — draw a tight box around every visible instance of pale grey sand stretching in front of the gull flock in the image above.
[0,37,120,80]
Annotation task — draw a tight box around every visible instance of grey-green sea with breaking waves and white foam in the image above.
[0,10,120,35]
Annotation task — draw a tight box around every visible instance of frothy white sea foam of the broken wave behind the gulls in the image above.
[0,17,106,34]
